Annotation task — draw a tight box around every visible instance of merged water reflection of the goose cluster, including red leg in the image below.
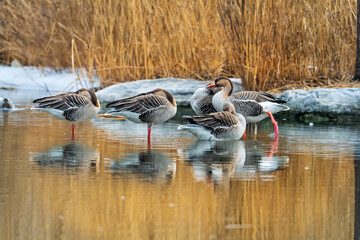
[187,138,289,184]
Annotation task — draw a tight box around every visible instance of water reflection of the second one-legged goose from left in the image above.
[105,149,176,180]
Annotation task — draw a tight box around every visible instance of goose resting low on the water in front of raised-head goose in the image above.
[178,103,246,141]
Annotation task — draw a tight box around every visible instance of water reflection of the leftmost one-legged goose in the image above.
[30,142,99,169]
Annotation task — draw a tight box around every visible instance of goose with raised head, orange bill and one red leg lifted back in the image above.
[208,77,289,135]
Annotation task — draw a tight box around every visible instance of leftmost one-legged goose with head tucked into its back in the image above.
[33,88,100,140]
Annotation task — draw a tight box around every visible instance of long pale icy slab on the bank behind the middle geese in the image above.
[96,77,241,107]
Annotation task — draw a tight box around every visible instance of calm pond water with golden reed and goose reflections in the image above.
[0,96,360,239]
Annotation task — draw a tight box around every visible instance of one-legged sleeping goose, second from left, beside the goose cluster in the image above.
[106,88,176,148]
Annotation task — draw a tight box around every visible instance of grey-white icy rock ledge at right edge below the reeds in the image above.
[277,88,360,115]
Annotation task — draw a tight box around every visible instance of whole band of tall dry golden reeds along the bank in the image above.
[0,0,356,90]
